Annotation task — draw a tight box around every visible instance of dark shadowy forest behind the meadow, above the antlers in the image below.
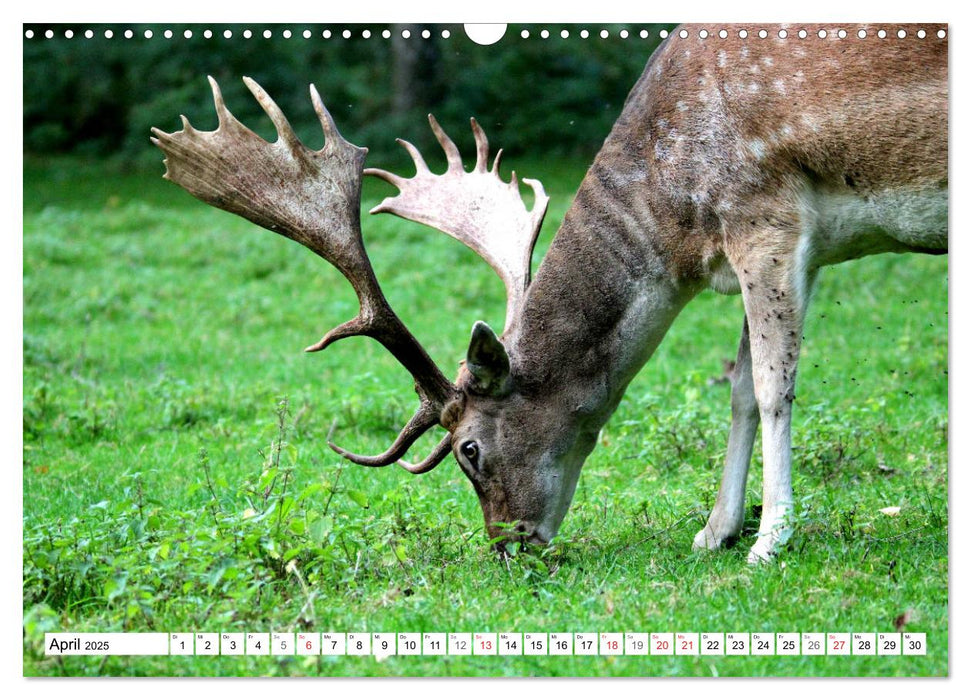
[23,24,670,170]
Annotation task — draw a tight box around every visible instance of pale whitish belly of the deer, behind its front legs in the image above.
[800,188,947,267]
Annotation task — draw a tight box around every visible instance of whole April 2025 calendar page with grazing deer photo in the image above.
[22,7,950,678]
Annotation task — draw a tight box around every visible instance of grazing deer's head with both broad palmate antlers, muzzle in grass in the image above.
[152,78,580,542]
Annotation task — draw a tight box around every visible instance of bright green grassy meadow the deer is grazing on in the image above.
[23,156,948,676]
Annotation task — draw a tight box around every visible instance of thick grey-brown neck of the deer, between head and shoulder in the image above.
[506,152,703,430]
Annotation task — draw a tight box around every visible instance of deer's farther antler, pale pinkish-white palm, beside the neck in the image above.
[364,114,549,330]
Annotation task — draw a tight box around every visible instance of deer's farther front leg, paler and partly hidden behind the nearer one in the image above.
[694,319,759,549]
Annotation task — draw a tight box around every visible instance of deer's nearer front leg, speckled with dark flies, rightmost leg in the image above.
[740,246,813,563]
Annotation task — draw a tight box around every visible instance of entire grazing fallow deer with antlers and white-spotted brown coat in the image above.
[153,26,948,562]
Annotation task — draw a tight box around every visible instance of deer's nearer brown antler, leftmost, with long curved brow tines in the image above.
[152,77,458,473]
